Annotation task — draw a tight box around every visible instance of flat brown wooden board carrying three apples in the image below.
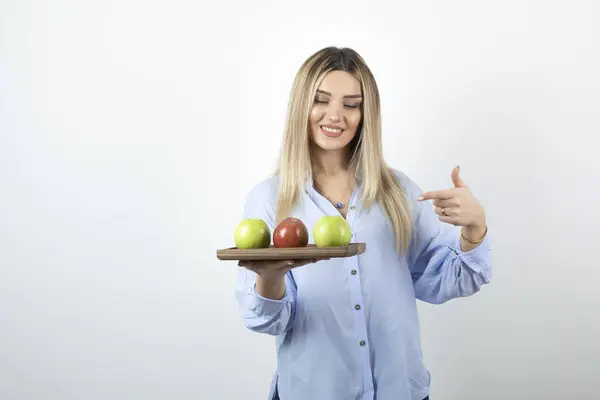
[217,243,367,261]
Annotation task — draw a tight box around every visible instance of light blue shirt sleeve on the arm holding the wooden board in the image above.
[235,182,296,335]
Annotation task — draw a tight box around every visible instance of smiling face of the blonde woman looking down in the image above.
[309,71,362,150]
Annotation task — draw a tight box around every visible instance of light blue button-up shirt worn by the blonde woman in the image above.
[236,171,491,400]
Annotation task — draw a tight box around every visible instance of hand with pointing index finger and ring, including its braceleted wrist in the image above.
[418,166,486,230]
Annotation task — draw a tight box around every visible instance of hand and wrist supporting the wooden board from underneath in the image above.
[238,258,329,300]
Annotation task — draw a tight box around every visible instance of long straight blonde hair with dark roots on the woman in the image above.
[275,47,412,252]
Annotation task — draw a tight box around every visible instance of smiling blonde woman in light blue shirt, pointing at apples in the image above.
[236,47,491,400]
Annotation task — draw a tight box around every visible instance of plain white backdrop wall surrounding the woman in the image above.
[0,0,600,400]
